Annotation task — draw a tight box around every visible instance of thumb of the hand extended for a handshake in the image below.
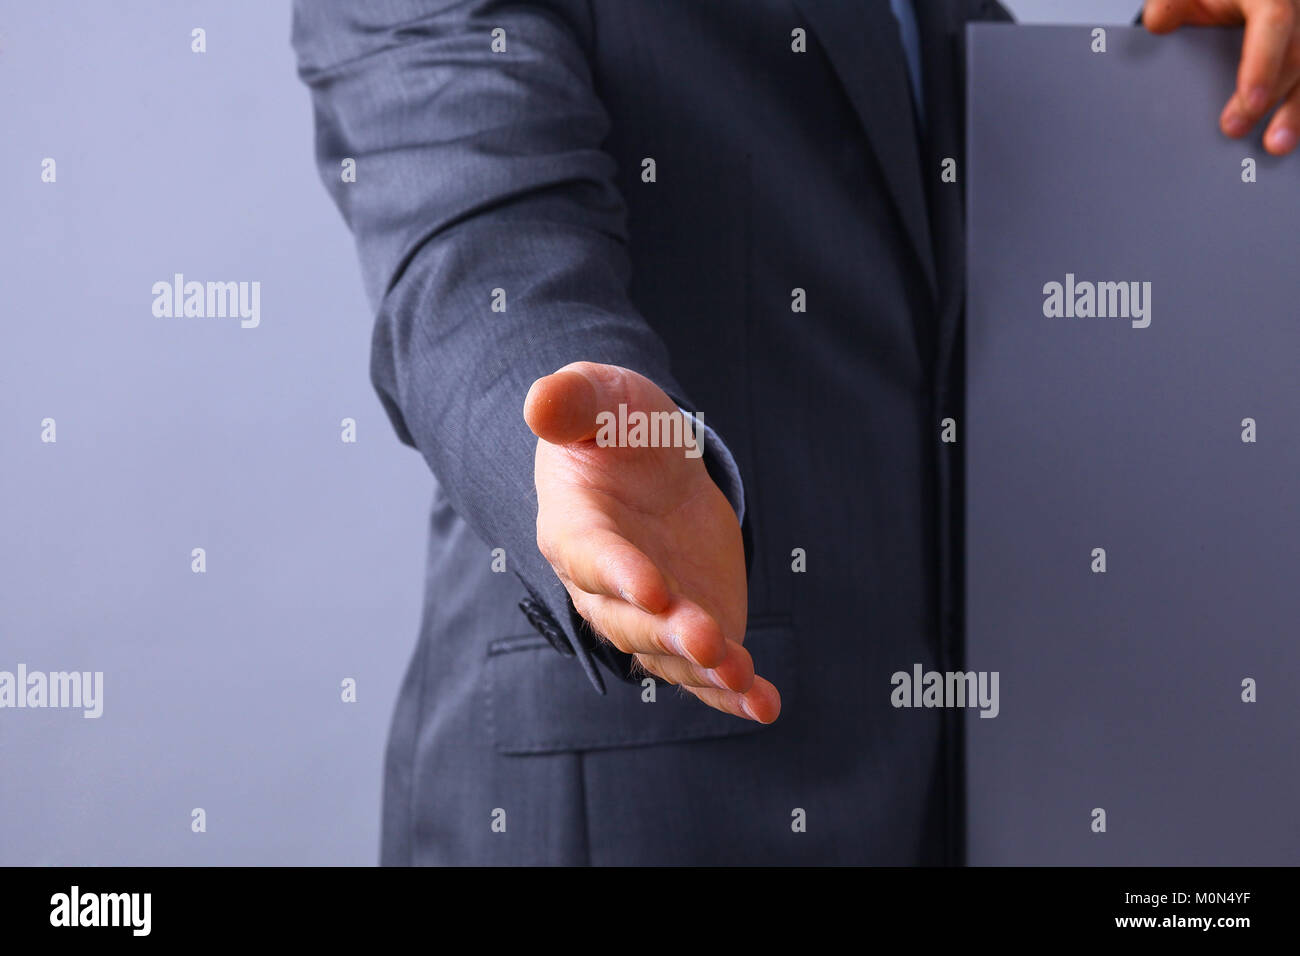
[524,362,677,445]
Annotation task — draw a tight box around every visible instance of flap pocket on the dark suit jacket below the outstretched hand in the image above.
[484,617,796,754]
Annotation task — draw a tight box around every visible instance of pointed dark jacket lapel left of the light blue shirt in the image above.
[796,0,939,299]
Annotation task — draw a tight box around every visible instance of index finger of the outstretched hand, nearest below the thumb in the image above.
[537,529,672,614]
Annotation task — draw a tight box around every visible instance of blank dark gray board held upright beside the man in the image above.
[959,26,1300,865]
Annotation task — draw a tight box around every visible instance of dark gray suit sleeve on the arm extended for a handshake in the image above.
[293,0,692,693]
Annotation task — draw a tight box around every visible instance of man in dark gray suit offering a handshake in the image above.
[294,0,1300,864]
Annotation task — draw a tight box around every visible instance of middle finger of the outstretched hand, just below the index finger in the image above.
[569,591,733,669]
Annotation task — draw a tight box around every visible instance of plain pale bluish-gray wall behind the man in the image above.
[0,0,1154,864]
